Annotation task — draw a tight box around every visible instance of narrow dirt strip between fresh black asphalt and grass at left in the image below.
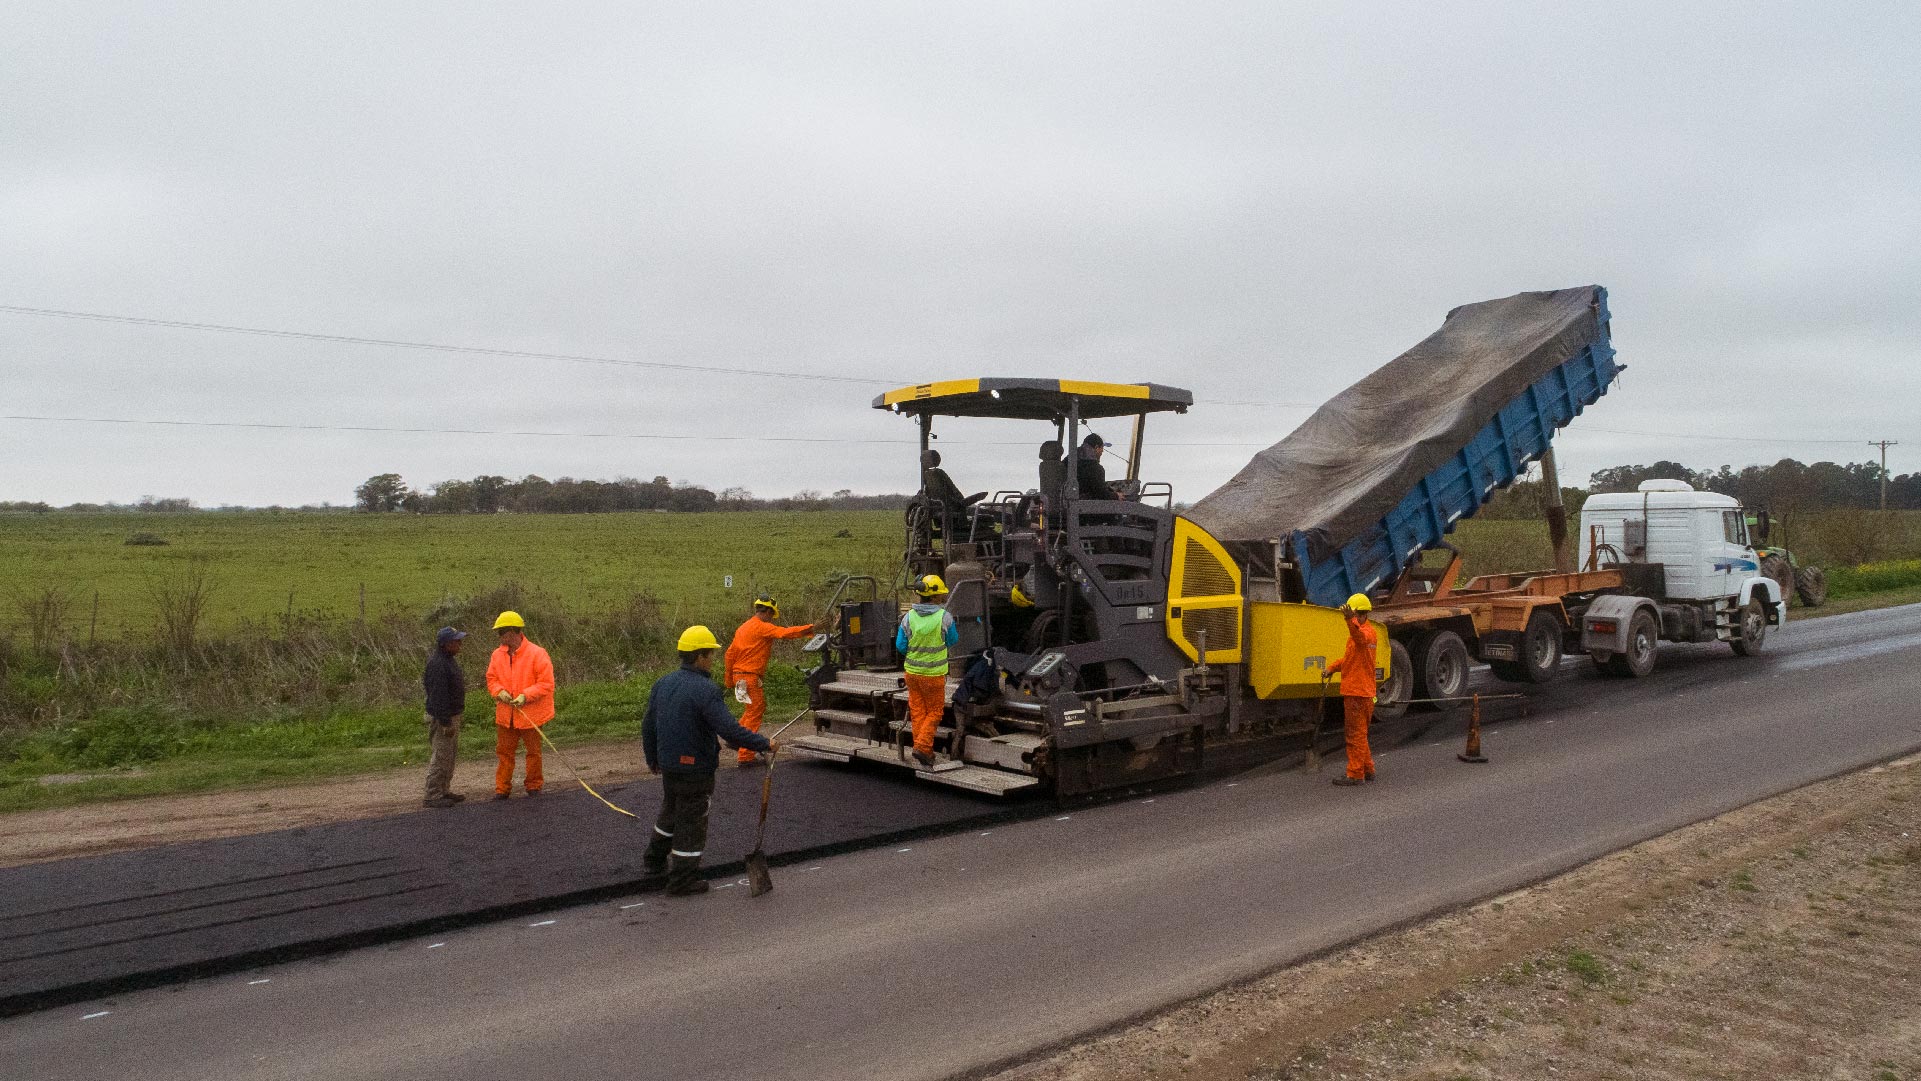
[0,739,676,866]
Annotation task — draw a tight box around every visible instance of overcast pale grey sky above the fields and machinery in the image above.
[0,0,1921,505]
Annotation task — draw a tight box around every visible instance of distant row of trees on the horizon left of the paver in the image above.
[353,472,909,515]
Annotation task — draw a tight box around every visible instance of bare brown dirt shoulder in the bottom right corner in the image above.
[997,758,1921,1081]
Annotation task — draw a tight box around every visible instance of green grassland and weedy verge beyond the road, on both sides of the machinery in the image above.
[0,513,1921,810]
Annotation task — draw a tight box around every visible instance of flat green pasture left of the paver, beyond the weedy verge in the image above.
[0,511,901,639]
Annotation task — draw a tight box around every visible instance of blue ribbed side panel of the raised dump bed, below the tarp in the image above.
[1289,294,1621,605]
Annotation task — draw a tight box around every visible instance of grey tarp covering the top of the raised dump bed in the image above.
[1187,286,1600,559]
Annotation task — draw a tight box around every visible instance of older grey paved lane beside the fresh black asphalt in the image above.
[15,607,1921,1081]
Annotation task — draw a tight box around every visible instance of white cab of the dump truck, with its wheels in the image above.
[1581,480,1787,674]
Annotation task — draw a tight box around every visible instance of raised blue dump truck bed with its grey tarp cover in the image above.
[1187,286,1621,605]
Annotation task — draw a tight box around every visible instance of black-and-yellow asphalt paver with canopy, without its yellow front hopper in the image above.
[788,378,1339,795]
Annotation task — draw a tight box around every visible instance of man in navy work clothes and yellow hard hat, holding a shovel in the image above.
[640,626,774,895]
